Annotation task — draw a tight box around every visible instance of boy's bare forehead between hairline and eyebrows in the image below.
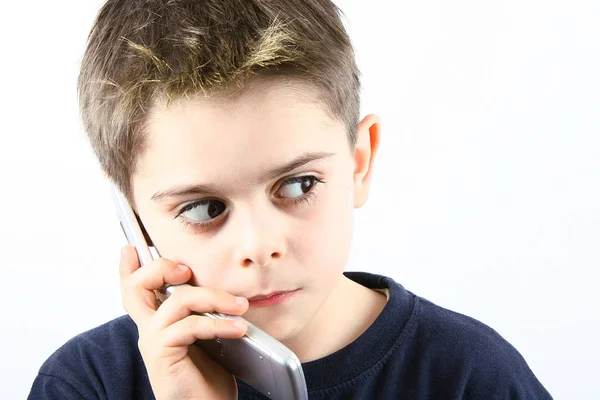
[134,79,348,195]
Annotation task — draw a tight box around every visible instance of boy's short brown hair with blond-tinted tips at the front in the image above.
[78,0,360,205]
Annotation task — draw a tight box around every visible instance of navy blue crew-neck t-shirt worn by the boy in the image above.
[29,272,552,400]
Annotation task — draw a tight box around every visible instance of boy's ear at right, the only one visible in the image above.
[354,114,381,208]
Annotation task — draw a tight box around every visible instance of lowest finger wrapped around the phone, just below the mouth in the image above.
[163,315,248,347]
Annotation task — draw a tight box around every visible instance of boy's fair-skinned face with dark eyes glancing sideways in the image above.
[132,83,380,340]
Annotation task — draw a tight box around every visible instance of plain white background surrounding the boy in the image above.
[0,0,600,399]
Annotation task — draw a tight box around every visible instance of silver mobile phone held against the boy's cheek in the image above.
[109,182,308,400]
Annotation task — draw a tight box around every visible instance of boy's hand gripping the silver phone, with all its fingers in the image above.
[119,246,248,400]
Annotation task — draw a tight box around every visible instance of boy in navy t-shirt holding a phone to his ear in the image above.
[30,0,550,399]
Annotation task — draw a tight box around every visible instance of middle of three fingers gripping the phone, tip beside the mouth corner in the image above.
[153,286,248,329]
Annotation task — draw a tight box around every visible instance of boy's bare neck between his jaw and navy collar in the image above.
[283,276,387,363]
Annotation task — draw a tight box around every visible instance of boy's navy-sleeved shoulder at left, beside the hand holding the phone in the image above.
[29,315,152,399]
